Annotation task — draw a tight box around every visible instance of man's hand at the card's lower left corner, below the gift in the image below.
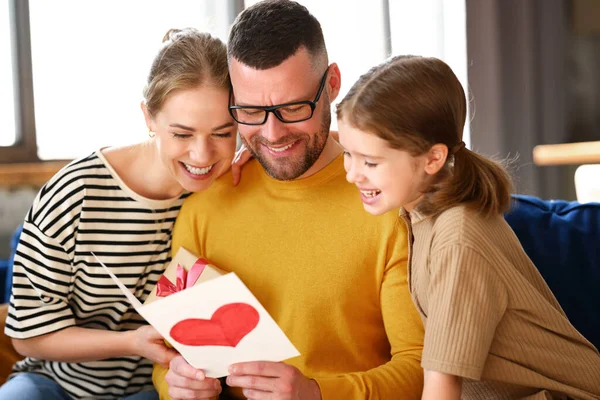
[165,356,222,400]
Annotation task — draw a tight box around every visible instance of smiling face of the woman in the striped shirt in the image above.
[150,86,237,192]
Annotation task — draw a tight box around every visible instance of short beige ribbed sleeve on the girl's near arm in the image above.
[421,245,508,380]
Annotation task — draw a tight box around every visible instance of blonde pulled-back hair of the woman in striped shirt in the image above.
[144,28,231,115]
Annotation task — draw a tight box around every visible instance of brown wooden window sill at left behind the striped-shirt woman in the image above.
[0,160,70,188]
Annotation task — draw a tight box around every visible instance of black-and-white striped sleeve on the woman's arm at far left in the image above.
[5,164,83,339]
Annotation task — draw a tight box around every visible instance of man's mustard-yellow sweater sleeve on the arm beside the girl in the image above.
[315,221,424,400]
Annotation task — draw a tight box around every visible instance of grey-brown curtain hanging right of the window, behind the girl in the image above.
[467,0,574,198]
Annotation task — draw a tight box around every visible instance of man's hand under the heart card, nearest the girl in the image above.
[227,361,321,400]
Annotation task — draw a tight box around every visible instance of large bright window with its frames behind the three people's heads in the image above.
[0,0,468,163]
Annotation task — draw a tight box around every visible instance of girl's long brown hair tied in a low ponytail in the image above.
[337,56,512,215]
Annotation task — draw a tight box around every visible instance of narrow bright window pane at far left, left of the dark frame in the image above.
[0,1,16,146]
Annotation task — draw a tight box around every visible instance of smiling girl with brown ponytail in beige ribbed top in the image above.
[337,56,600,400]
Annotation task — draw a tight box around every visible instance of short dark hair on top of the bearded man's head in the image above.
[227,0,328,70]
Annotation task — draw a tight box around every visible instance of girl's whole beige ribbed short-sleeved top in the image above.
[401,206,600,399]
